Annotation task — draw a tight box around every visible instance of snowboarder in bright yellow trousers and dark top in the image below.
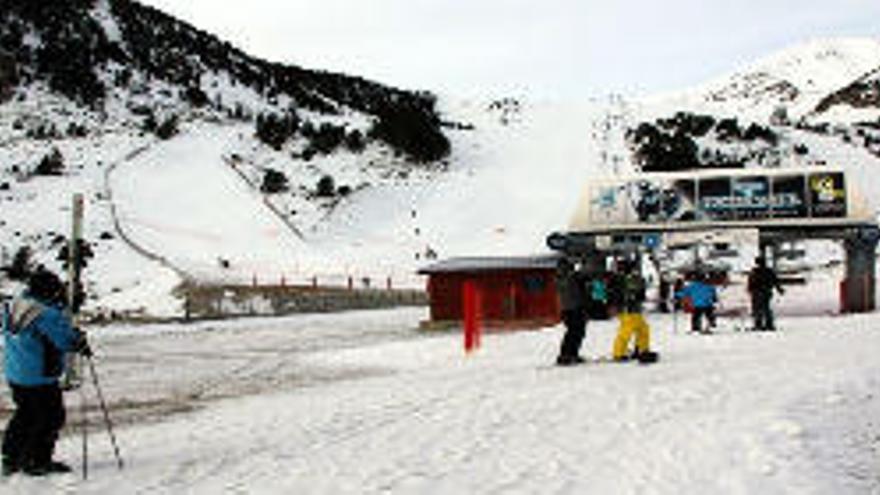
[611,260,657,363]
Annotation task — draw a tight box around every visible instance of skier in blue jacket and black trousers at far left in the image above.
[2,268,91,476]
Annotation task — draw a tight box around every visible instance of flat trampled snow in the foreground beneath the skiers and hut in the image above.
[0,272,880,494]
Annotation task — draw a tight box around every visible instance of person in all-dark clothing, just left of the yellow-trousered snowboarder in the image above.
[556,257,587,366]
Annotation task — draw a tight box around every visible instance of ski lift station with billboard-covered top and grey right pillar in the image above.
[547,167,880,312]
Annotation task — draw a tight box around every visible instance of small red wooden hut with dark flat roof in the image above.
[419,255,559,328]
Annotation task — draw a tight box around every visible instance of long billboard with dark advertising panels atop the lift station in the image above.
[572,169,853,232]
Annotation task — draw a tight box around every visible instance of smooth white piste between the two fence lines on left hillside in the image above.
[109,125,312,282]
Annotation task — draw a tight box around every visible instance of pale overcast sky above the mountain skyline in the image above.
[141,0,880,99]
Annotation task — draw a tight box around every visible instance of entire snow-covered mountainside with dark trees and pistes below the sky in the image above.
[0,0,880,316]
